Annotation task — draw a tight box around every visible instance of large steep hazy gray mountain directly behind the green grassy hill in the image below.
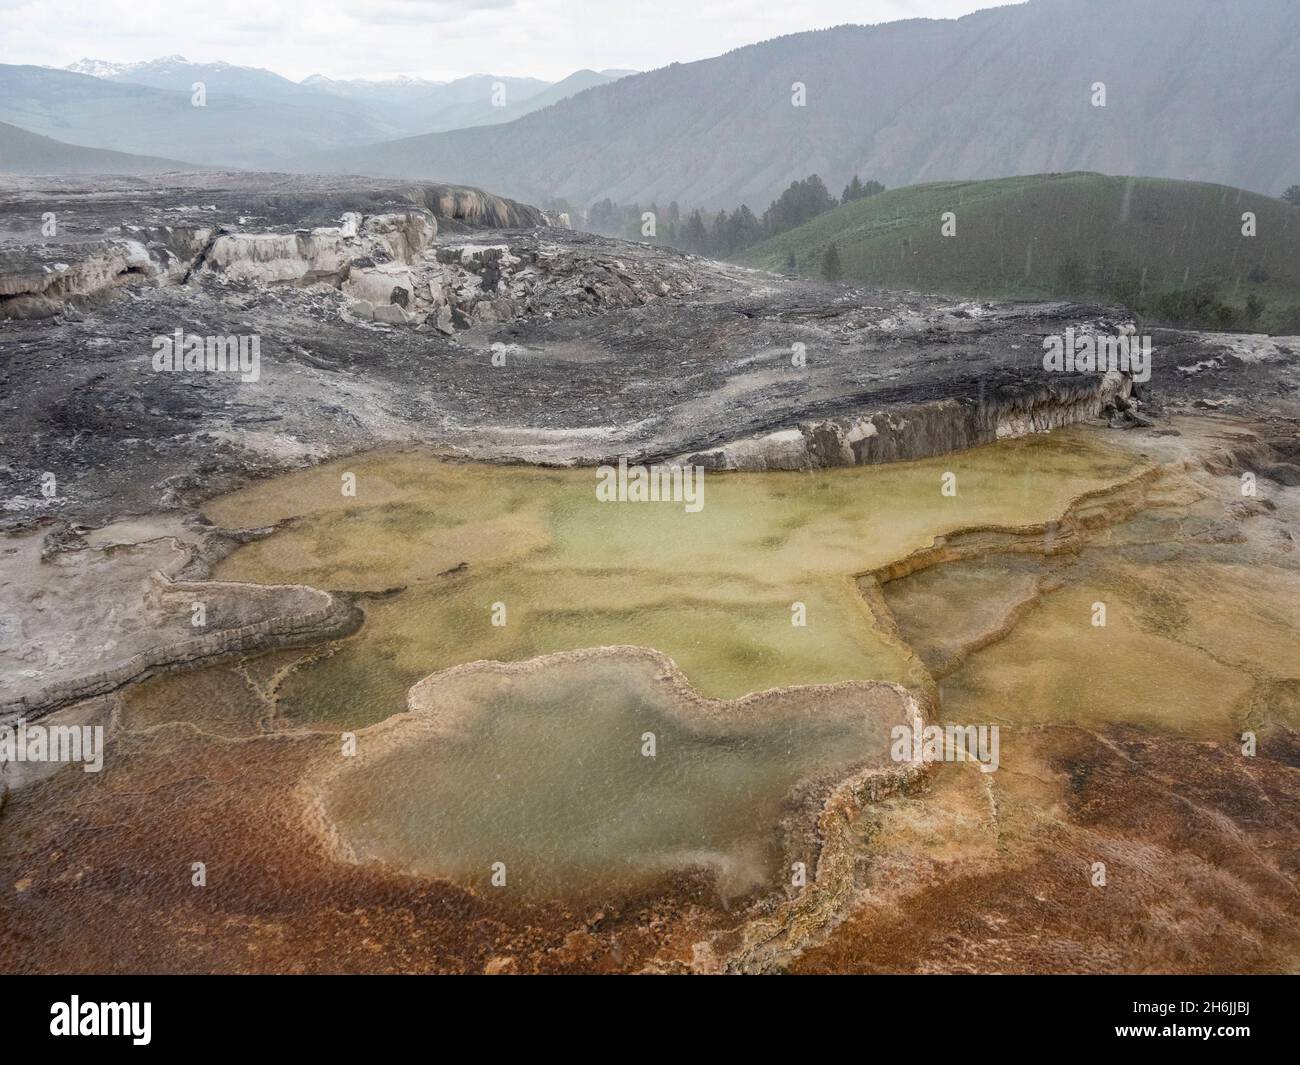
[294,0,1300,209]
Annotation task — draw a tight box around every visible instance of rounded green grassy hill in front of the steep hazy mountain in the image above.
[738,173,1300,333]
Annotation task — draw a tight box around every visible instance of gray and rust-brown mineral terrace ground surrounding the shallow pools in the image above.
[0,173,1300,971]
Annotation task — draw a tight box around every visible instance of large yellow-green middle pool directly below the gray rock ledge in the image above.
[197,432,1136,727]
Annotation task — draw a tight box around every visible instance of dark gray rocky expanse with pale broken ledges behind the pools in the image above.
[0,176,1300,527]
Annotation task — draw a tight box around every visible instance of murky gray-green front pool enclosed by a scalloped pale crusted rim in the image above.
[325,661,888,895]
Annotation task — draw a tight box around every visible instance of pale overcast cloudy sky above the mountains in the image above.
[0,0,998,79]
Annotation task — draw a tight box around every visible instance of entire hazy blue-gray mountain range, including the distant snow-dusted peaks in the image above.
[0,0,1300,211]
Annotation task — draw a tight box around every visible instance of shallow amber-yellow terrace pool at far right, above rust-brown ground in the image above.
[885,477,1300,745]
